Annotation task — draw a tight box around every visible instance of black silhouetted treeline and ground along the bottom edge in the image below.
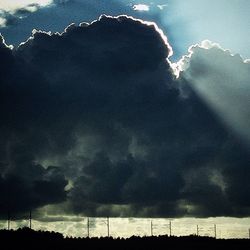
[0,228,250,250]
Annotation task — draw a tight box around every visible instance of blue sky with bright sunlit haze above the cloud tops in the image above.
[0,0,250,61]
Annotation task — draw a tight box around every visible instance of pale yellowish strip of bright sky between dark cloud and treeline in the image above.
[0,215,250,239]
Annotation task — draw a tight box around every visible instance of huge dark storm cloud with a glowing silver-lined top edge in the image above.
[0,16,250,219]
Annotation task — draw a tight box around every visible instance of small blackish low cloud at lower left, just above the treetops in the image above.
[0,165,67,218]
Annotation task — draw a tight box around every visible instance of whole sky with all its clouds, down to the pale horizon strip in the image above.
[0,0,250,238]
